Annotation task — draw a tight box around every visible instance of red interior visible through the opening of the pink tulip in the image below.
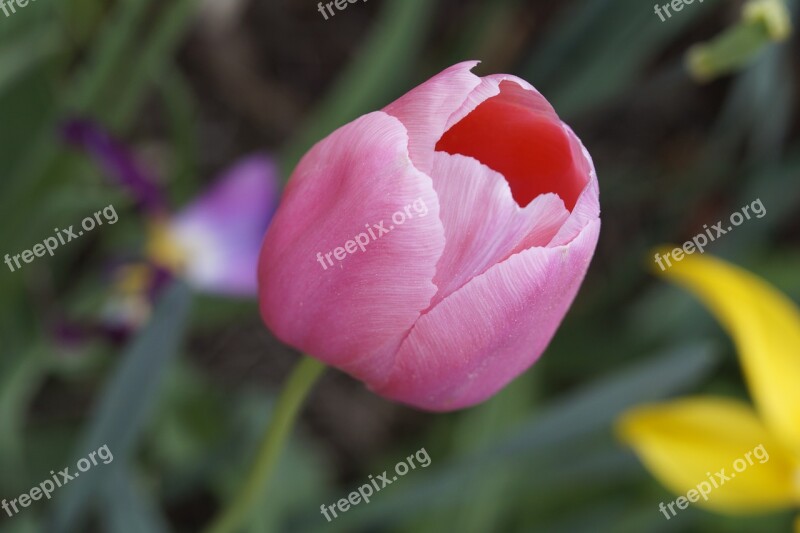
[436,81,588,211]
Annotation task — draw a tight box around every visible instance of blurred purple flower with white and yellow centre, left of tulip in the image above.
[59,119,280,335]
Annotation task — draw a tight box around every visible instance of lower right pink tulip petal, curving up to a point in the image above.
[370,220,600,411]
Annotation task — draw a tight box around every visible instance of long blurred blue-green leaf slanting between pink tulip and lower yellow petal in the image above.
[308,344,717,530]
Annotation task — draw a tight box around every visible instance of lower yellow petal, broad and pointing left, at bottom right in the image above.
[617,397,800,514]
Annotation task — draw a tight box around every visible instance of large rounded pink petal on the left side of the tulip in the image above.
[259,112,444,380]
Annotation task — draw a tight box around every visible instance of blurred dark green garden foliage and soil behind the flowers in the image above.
[0,0,800,533]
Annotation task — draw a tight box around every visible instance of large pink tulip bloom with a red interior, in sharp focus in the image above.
[258,62,600,411]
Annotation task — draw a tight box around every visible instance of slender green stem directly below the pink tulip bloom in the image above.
[206,357,325,533]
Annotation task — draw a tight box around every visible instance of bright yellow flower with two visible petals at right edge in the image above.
[617,249,800,533]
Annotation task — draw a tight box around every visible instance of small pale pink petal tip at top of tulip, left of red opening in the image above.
[383,61,481,173]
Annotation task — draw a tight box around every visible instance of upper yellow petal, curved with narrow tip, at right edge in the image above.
[656,250,800,456]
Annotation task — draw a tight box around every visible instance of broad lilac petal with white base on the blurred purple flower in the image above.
[169,155,279,296]
